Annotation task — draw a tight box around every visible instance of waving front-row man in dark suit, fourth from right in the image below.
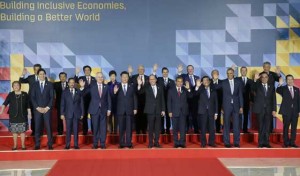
[194,76,218,148]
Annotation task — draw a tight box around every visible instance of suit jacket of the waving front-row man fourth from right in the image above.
[194,86,218,116]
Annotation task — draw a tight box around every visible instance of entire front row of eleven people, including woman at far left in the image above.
[0,68,300,150]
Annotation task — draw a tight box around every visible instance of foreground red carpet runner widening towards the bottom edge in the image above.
[48,158,233,176]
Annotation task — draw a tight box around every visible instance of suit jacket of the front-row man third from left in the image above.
[60,88,84,119]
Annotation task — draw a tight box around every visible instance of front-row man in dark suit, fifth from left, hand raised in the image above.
[114,71,138,148]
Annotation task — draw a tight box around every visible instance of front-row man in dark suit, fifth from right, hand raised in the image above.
[167,76,193,148]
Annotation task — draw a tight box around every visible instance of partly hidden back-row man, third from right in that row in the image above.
[210,70,223,133]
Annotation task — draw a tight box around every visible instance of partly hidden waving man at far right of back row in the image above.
[263,61,281,133]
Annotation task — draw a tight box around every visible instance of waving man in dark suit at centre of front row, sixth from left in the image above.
[138,75,165,148]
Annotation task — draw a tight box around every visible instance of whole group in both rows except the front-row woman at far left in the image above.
[20,62,300,150]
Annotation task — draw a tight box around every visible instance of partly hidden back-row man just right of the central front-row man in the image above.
[157,67,175,134]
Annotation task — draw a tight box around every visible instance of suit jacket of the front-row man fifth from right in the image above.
[167,86,193,117]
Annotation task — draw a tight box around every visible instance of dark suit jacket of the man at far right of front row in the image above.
[276,85,300,117]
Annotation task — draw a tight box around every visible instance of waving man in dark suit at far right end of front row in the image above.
[276,75,300,148]
